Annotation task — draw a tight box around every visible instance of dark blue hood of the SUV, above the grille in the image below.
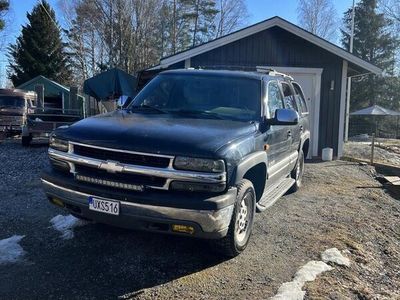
[55,110,256,157]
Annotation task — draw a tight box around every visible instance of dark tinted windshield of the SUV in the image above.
[128,74,261,121]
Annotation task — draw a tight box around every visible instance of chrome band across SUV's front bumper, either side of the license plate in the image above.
[41,179,234,232]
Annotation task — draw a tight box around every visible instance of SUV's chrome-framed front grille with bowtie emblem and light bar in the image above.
[49,142,226,190]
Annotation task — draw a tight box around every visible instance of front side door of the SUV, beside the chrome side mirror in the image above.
[265,80,291,183]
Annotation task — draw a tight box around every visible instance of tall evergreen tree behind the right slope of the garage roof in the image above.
[342,0,398,110]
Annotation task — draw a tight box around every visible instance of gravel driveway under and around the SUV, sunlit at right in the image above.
[0,140,400,299]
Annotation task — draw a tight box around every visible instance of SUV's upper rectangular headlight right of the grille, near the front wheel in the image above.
[174,156,225,173]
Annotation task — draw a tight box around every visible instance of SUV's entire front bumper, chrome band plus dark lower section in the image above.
[42,176,236,239]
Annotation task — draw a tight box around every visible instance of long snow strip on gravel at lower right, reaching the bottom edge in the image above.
[271,260,333,300]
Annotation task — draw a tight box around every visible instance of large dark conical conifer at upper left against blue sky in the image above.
[8,1,70,86]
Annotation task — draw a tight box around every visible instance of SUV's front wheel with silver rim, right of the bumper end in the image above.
[213,179,256,258]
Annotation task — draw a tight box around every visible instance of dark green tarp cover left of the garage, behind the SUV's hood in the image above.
[83,68,136,100]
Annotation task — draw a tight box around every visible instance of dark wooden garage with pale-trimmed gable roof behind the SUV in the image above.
[150,17,382,157]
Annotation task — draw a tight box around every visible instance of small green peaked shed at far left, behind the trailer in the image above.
[17,75,84,112]
